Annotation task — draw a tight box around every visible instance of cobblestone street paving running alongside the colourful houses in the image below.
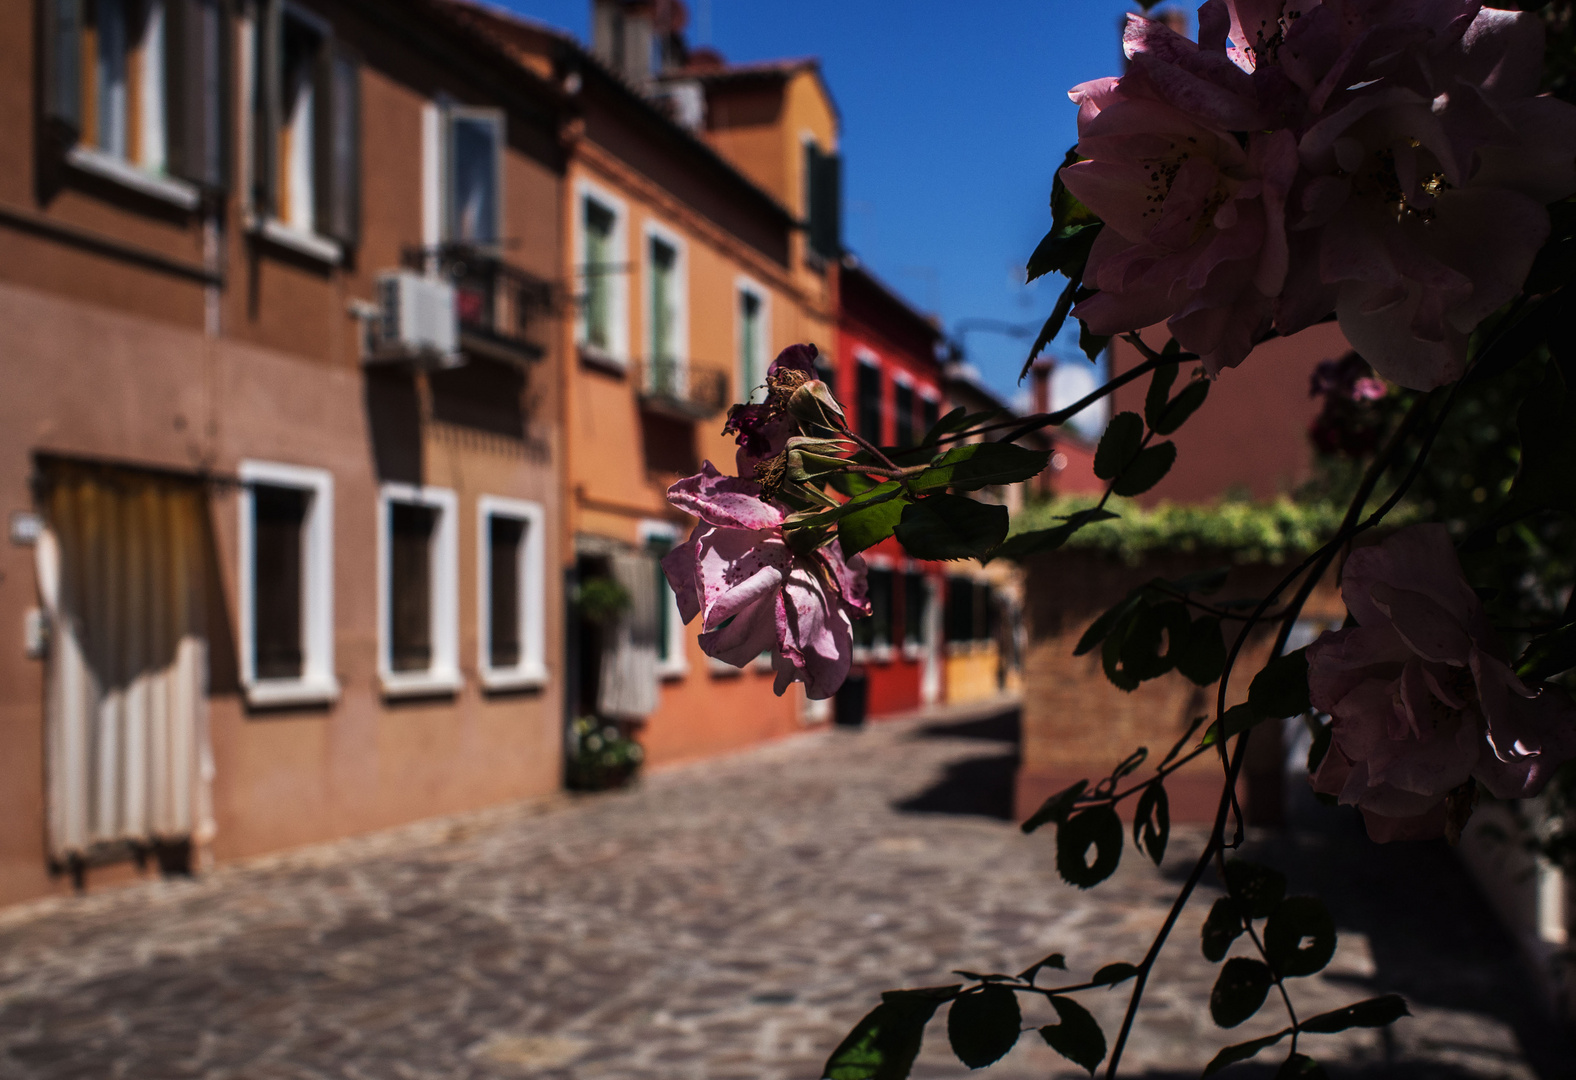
[0,703,1576,1080]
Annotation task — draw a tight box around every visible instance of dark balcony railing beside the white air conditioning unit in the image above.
[405,244,555,363]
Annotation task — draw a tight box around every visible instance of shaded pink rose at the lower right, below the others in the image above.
[1308,525,1576,842]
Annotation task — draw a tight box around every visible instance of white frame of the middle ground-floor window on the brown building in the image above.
[377,484,462,697]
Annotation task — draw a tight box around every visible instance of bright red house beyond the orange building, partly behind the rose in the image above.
[829,255,946,716]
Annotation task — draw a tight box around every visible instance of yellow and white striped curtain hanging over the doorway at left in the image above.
[38,465,213,859]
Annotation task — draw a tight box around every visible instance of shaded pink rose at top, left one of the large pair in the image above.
[1061,16,1297,372]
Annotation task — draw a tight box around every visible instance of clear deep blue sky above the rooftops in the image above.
[506,0,1159,409]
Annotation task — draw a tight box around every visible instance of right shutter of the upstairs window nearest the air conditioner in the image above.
[312,41,361,246]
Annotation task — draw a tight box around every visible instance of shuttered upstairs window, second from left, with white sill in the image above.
[252,0,361,250]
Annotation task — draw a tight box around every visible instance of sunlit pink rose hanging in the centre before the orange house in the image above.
[662,462,870,698]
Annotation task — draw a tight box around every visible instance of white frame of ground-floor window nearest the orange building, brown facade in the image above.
[476,495,547,691]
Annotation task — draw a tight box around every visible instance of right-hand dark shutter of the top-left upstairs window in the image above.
[164,0,229,191]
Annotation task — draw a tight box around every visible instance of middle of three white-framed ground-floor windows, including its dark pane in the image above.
[378,484,460,695]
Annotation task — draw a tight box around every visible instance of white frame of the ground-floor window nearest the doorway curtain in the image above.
[236,460,339,708]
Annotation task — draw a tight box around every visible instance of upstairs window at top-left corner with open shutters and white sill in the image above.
[43,0,224,210]
